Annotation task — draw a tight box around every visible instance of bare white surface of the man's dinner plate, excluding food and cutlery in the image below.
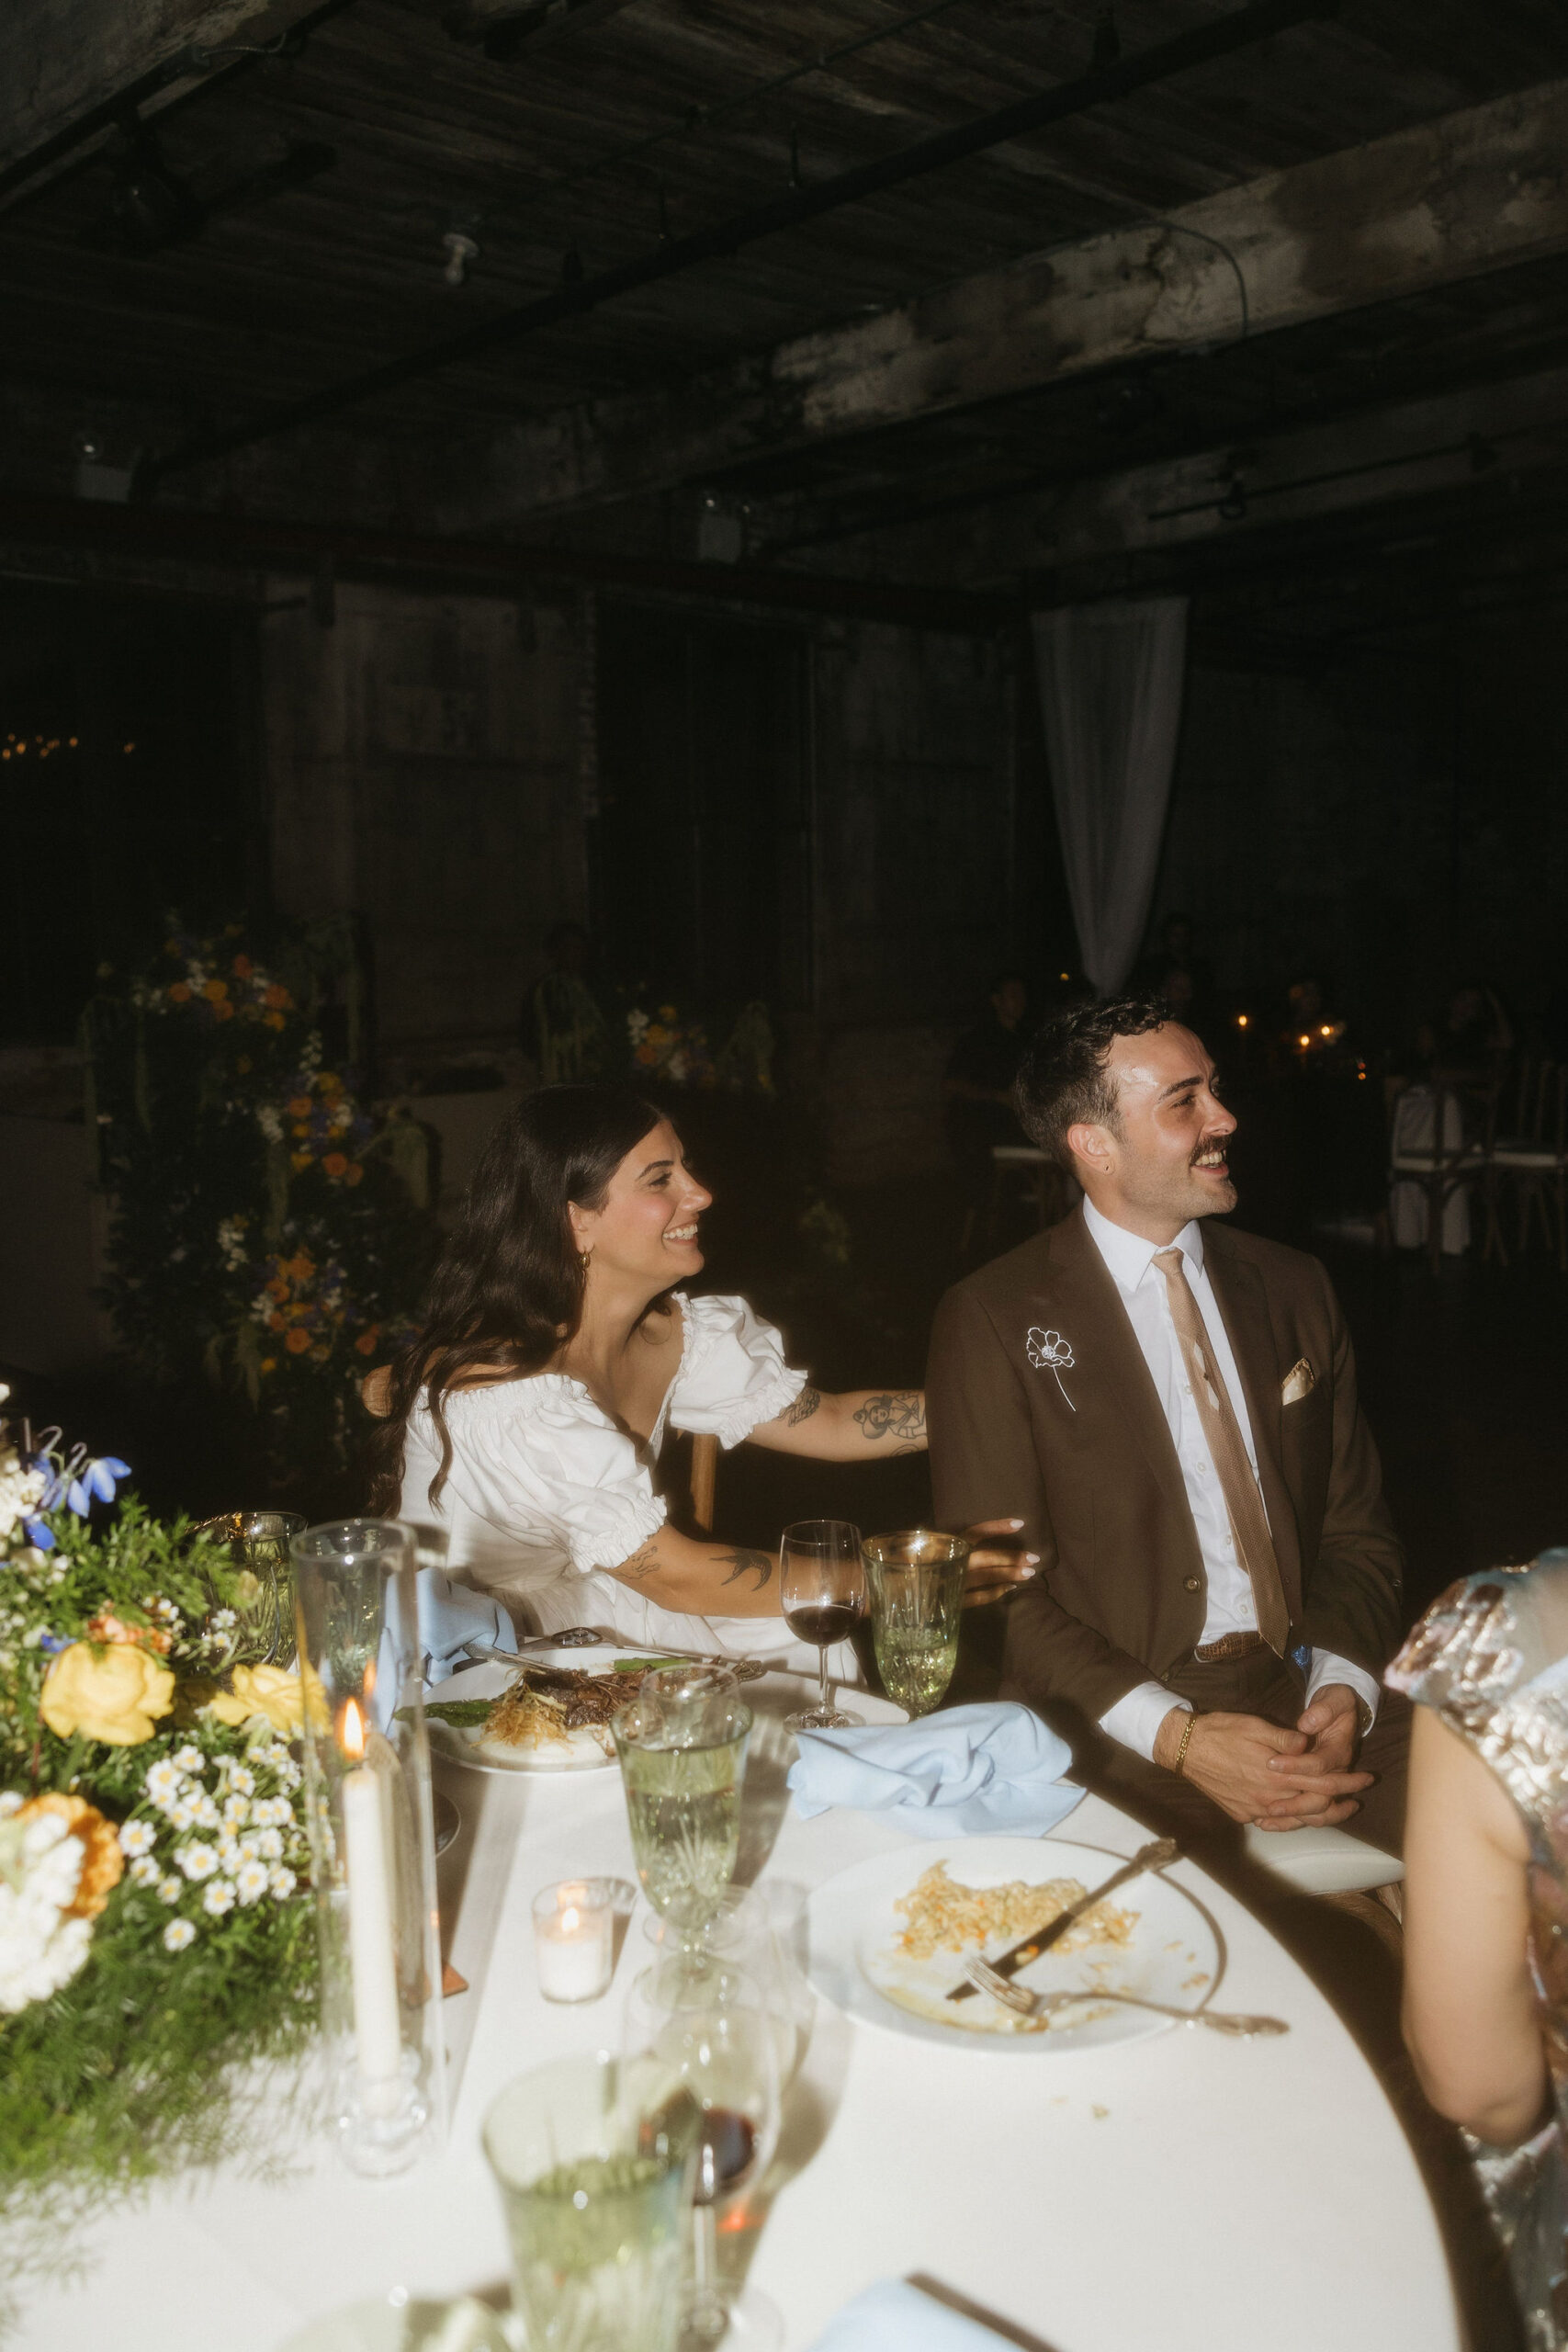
[807,1837,1220,2058]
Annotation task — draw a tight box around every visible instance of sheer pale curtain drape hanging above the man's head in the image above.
[1034,597,1187,995]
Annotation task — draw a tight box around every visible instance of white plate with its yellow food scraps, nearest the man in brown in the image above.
[807,1837,1220,2055]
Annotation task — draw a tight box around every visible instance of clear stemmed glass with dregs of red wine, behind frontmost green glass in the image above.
[626,1954,783,2352]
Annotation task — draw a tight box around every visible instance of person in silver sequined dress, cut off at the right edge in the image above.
[1384,1547,1568,2352]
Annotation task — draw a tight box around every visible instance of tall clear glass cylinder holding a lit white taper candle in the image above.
[294,1520,446,2176]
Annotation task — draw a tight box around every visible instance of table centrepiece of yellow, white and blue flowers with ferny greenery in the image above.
[0,1387,322,2269]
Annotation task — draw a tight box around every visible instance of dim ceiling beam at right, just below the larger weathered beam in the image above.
[822,367,1568,581]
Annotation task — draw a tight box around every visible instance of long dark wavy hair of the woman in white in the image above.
[367,1087,670,1515]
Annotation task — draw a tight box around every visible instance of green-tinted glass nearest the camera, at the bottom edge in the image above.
[484,2051,703,2352]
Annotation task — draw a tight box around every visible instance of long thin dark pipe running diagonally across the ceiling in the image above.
[150,0,1337,489]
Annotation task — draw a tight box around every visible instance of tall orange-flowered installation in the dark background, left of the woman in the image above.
[85,924,434,1465]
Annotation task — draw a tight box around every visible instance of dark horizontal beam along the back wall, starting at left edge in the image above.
[0,496,1021,635]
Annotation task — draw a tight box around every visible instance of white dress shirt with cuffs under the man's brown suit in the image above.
[1084,1200,1378,1761]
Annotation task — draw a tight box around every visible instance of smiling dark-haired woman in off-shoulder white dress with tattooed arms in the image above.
[365,1087,1034,1679]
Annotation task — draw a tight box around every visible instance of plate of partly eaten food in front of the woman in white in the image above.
[425,1644,670,1773]
